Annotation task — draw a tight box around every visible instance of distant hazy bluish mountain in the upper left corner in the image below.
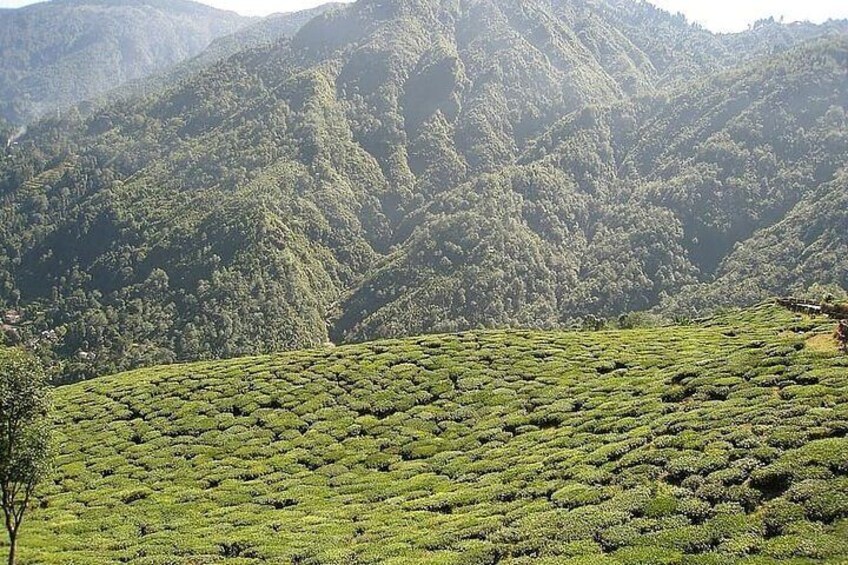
[0,0,251,123]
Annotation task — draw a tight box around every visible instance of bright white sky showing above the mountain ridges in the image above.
[0,0,848,31]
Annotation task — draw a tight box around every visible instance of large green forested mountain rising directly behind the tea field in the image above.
[0,0,848,382]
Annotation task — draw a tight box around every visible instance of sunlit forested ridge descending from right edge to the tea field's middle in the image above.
[337,39,848,339]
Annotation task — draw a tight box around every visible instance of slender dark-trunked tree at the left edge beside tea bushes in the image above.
[0,349,51,565]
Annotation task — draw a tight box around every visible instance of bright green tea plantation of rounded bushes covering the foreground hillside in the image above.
[14,306,848,565]
